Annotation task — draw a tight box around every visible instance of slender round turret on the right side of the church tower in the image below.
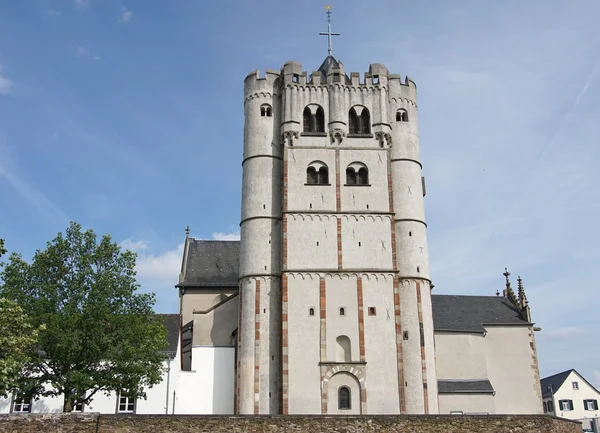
[387,75,438,413]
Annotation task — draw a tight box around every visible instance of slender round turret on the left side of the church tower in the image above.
[236,70,281,414]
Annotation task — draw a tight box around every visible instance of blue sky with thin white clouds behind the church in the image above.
[0,0,600,385]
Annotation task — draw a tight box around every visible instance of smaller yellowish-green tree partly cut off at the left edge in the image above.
[0,298,43,397]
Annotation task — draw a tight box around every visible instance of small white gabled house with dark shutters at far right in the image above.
[541,369,600,432]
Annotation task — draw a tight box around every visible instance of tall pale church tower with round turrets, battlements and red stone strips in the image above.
[236,8,438,414]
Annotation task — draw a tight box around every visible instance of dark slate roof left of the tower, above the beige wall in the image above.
[177,238,240,287]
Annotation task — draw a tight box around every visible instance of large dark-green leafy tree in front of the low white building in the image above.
[0,222,166,412]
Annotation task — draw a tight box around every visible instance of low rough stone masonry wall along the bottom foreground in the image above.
[0,413,582,433]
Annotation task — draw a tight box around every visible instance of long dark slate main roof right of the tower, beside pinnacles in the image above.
[431,295,529,332]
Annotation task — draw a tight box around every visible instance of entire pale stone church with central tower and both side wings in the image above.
[177,55,542,414]
